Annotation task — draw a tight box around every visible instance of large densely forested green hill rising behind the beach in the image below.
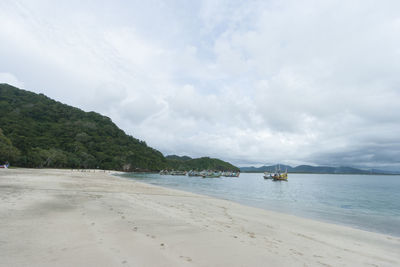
[0,84,167,171]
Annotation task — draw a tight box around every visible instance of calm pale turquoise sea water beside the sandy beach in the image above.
[124,173,400,236]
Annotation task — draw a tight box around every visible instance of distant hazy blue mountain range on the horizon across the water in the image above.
[240,164,398,174]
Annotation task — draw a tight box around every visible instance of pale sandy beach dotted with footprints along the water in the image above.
[0,169,400,266]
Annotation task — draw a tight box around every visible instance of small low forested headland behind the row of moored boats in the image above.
[166,155,239,171]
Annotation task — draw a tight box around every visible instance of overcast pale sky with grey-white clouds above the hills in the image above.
[0,0,400,170]
